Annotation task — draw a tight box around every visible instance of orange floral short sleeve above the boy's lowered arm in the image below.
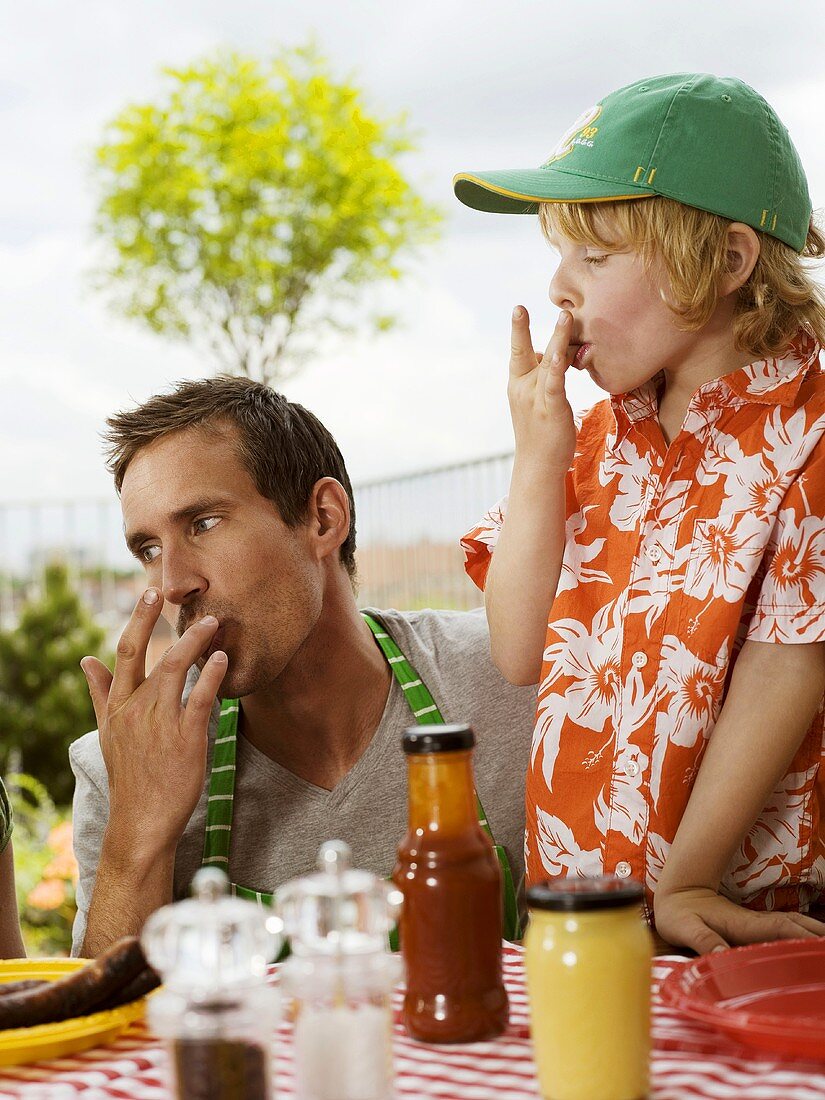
[747,442,825,644]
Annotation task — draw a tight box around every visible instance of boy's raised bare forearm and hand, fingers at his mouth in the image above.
[484,306,575,684]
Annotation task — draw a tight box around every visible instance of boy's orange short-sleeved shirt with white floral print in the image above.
[462,332,825,911]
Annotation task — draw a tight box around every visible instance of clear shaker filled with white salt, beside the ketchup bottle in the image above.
[275,840,403,1100]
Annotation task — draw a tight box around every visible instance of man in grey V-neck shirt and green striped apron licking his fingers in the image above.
[70,378,535,955]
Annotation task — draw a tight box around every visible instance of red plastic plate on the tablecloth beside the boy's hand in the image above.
[661,939,825,1060]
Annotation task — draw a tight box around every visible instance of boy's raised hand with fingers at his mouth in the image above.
[507,306,575,473]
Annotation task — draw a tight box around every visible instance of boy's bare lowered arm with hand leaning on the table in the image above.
[653,641,825,954]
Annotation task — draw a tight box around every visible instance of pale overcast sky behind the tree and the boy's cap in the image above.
[0,0,825,503]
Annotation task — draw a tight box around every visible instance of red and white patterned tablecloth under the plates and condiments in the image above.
[0,945,825,1100]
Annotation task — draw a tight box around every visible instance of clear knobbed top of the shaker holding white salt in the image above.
[275,840,403,956]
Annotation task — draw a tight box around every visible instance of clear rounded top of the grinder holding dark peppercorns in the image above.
[141,867,281,998]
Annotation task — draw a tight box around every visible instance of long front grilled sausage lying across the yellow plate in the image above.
[0,936,146,1030]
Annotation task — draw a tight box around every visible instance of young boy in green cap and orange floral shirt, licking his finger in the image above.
[455,74,825,953]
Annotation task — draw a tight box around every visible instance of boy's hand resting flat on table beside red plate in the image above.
[653,887,825,955]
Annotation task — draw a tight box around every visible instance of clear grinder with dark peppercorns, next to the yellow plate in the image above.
[141,867,281,1100]
